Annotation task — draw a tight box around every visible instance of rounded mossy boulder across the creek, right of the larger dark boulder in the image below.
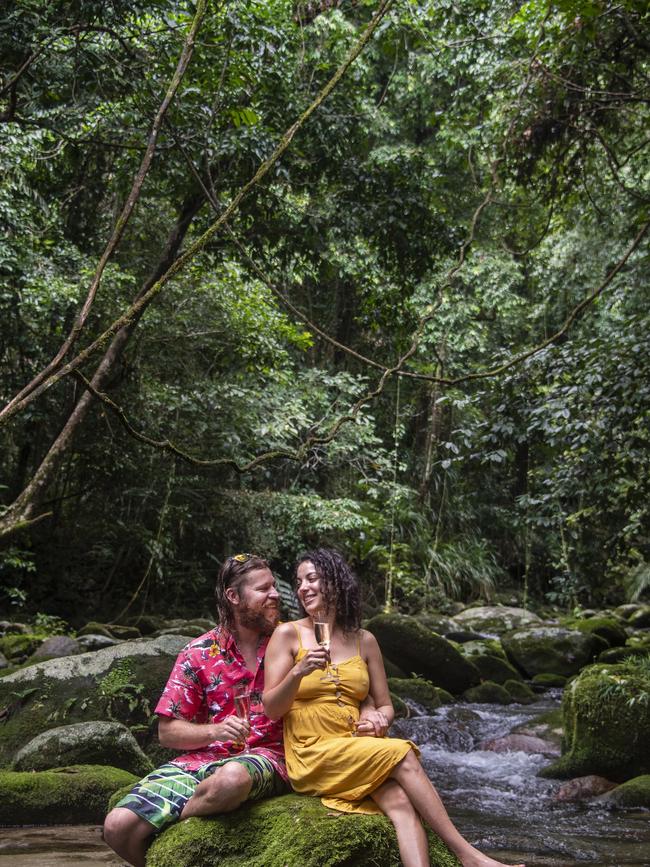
[501,626,607,677]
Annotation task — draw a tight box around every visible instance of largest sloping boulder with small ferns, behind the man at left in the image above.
[0,635,188,767]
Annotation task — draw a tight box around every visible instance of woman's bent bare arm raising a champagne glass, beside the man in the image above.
[262,623,327,719]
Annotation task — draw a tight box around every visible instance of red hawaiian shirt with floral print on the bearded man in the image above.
[156,626,287,780]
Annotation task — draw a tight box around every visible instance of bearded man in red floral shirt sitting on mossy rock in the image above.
[104,554,289,867]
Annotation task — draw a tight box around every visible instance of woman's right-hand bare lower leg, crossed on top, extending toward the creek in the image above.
[391,750,524,867]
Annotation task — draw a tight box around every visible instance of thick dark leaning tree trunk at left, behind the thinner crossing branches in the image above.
[0,194,205,539]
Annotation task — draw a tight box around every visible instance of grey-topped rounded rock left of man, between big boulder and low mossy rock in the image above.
[11,720,153,777]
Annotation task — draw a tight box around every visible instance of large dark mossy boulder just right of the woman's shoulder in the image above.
[367,614,480,695]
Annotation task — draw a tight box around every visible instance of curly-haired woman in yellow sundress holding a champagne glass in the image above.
[264,548,523,867]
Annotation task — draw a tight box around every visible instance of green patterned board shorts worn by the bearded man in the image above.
[115,753,289,831]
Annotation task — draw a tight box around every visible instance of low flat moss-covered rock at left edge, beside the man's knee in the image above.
[0,765,138,825]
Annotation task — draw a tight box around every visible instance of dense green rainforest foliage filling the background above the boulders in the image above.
[0,0,650,622]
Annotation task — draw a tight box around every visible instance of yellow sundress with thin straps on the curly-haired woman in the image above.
[284,627,419,813]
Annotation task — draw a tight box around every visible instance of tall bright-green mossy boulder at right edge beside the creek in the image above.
[542,659,650,782]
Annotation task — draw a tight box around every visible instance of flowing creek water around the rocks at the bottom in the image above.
[0,693,650,867]
